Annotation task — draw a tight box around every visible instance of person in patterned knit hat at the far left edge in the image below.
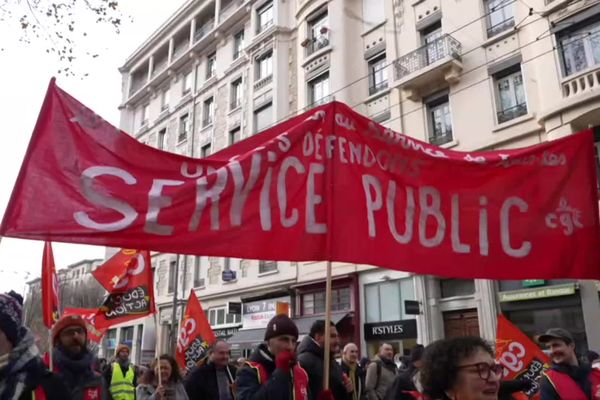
[0,291,71,400]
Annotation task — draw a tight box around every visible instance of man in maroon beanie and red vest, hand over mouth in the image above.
[236,314,309,400]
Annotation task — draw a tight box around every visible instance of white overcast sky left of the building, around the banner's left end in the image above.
[0,0,184,292]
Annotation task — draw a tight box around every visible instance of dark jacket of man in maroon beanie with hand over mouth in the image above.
[235,343,309,400]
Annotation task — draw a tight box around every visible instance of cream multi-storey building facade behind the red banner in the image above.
[120,0,600,355]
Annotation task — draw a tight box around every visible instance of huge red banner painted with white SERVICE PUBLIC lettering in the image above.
[0,78,600,279]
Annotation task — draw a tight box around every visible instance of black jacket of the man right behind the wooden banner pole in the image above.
[298,336,352,400]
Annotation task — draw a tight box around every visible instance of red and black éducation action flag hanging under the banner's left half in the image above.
[92,249,155,328]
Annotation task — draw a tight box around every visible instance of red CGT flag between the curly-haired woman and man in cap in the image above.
[496,315,550,400]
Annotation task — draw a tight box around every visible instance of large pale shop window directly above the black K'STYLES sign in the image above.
[365,278,416,322]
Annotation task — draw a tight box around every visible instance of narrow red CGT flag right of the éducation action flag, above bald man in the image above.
[177,290,216,368]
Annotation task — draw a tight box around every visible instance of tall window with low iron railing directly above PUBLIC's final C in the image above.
[494,65,527,124]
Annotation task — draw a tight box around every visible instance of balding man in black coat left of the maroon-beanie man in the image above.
[185,340,237,400]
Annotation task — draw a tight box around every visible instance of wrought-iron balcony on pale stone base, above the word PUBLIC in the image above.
[394,35,463,101]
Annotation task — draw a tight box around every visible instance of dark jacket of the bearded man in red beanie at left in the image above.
[52,347,108,400]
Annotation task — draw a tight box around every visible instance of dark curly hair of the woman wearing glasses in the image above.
[420,336,494,400]
